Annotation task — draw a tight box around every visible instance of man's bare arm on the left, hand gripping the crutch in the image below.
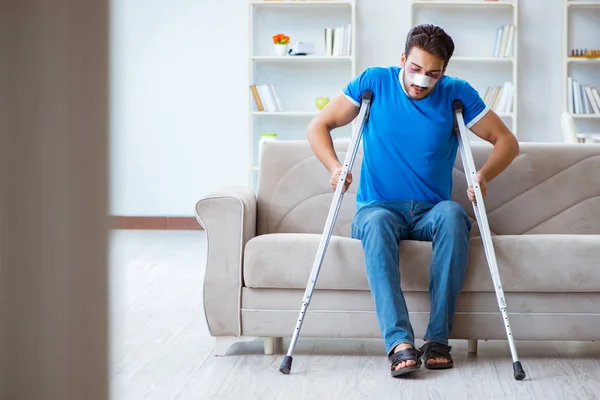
[306,93,360,191]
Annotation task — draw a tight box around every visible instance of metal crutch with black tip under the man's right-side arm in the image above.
[453,100,525,381]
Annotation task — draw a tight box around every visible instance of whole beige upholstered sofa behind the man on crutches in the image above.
[196,141,600,355]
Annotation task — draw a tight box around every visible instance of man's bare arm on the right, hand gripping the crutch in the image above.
[467,110,519,202]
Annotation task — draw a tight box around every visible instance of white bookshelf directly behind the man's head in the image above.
[409,0,519,136]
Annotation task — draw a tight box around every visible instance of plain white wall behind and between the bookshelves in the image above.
[111,0,563,216]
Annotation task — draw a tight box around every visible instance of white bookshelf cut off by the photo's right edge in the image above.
[562,0,600,133]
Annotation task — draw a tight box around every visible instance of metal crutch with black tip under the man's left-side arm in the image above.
[279,90,373,374]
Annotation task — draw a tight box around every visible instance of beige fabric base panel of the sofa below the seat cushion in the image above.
[241,288,600,340]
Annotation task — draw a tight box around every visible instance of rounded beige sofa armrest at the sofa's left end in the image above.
[196,186,256,336]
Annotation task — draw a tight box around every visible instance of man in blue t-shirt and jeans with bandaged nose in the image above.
[307,25,519,376]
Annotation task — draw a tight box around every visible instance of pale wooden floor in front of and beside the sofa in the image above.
[111,231,600,400]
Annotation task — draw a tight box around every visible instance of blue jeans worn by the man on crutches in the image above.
[352,201,471,355]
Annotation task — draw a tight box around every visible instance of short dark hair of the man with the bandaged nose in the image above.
[404,24,454,68]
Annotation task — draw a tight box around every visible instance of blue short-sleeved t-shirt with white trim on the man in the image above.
[343,67,489,208]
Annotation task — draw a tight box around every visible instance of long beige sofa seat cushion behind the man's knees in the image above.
[243,233,600,292]
